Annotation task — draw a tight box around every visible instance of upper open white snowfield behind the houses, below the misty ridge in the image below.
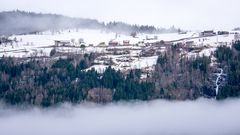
[0,29,234,57]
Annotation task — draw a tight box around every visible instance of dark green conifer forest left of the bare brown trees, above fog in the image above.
[0,53,154,106]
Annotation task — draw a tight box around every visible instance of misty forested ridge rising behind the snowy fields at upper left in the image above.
[0,10,178,35]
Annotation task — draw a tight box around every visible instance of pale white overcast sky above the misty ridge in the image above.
[0,0,240,29]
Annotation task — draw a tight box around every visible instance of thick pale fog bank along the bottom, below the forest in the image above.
[0,99,240,135]
